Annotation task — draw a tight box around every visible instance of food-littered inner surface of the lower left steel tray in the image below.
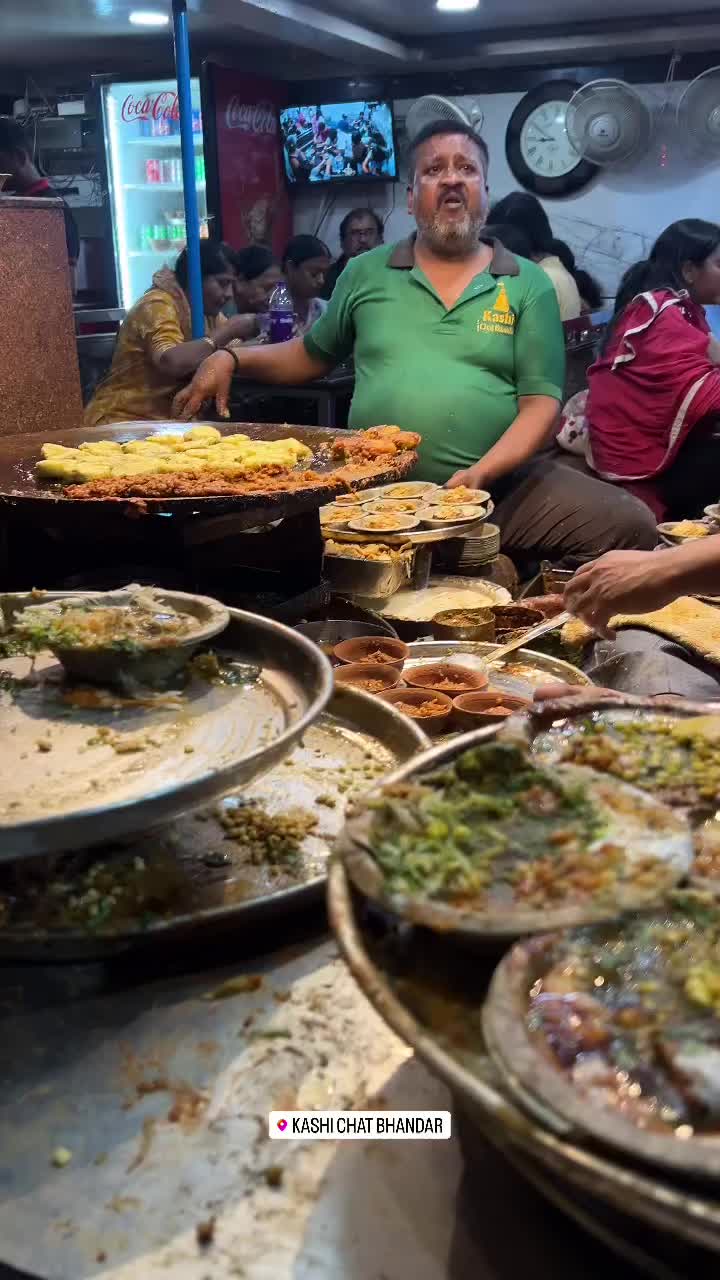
[0,716,396,937]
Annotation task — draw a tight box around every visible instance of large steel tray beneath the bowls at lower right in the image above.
[328,858,720,1280]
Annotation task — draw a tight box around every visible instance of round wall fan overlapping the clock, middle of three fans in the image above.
[565,81,652,165]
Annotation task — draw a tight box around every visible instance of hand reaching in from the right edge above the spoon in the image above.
[565,552,683,639]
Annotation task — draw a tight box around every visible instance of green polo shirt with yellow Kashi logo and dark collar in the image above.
[305,239,565,484]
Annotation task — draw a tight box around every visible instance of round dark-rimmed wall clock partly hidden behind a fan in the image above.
[505,81,598,196]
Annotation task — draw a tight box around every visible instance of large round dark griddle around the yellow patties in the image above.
[0,421,418,525]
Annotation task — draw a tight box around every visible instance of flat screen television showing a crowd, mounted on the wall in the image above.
[281,101,397,187]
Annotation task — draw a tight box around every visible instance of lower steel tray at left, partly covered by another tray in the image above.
[0,689,428,961]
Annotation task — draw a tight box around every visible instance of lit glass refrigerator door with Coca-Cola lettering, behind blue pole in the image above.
[102,79,208,311]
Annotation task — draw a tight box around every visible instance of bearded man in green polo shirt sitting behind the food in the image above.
[176,123,656,562]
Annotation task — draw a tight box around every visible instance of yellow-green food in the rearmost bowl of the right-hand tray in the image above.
[536,713,720,806]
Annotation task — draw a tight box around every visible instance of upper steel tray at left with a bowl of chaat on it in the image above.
[0,609,332,861]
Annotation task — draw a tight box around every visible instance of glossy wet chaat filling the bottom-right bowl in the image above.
[527,892,720,1140]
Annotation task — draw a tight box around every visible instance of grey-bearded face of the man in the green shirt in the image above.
[407,133,488,257]
